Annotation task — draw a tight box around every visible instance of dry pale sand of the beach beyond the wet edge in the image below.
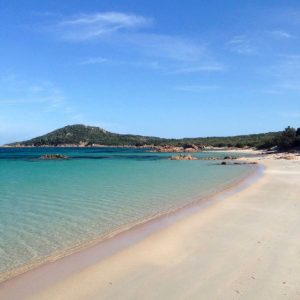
[0,156,300,300]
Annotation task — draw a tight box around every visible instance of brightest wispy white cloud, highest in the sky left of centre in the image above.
[47,12,151,42]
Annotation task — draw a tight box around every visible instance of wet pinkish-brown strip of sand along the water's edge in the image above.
[0,165,264,297]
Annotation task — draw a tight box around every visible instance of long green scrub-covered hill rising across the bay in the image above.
[10,125,281,147]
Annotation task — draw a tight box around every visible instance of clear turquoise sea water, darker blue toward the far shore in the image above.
[0,148,252,275]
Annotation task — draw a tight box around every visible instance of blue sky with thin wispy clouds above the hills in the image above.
[0,0,300,144]
